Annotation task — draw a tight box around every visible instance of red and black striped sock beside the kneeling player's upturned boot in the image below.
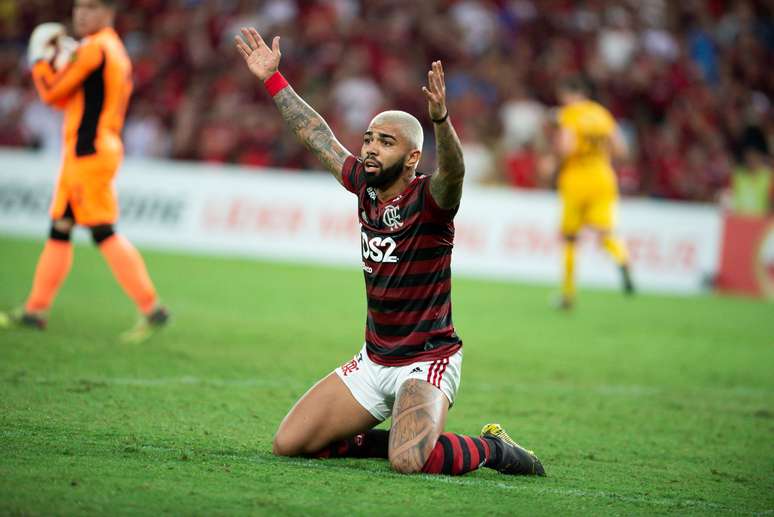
[422,433,490,476]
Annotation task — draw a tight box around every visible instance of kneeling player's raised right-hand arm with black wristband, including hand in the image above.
[422,61,465,209]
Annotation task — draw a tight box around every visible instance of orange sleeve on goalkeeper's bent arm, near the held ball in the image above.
[32,42,104,106]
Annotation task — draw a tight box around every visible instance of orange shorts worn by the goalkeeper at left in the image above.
[50,152,122,226]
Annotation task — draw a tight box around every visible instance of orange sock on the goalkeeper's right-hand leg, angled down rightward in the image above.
[99,234,158,315]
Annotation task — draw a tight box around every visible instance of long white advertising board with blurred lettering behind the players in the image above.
[0,150,721,293]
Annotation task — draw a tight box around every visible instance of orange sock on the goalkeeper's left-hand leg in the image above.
[24,239,73,313]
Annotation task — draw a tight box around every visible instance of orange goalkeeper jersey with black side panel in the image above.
[32,27,132,157]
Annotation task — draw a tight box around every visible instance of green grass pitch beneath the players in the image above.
[0,237,774,515]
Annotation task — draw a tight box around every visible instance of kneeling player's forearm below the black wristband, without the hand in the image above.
[430,119,465,208]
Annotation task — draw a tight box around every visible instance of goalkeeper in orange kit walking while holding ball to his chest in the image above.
[0,0,169,342]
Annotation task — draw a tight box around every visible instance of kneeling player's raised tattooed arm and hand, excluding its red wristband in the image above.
[236,27,350,183]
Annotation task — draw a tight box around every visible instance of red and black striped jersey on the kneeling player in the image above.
[342,156,462,366]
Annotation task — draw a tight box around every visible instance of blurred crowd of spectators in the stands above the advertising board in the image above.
[0,0,774,211]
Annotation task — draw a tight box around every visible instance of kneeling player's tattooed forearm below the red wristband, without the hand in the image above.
[274,86,349,183]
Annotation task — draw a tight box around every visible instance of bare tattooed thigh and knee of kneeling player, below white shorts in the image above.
[389,379,446,473]
